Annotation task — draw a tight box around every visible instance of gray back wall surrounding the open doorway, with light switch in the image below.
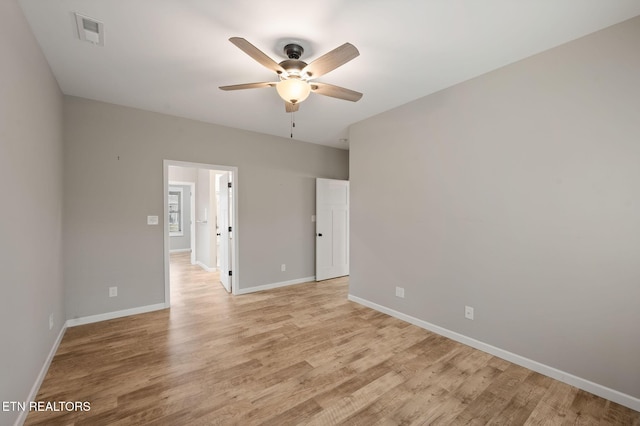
[64,97,349,318]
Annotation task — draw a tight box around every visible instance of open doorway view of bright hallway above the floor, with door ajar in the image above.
[163,160,240,307]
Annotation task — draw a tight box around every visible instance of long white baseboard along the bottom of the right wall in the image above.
[349,294,640,411]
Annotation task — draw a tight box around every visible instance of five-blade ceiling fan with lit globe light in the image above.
[220,37,362,112]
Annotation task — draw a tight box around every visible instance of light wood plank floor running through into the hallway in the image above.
[26,255,640,426]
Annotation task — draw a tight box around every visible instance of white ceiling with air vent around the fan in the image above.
[20,0,640,149]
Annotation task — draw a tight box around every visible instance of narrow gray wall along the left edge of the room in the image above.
[0,0,65,424]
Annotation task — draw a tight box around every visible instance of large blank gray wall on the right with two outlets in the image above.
[350,18,640,398]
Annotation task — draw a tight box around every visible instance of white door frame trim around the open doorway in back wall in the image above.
[162,160,240,308]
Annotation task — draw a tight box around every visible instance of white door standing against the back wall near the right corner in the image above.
[316,179,349,281]
